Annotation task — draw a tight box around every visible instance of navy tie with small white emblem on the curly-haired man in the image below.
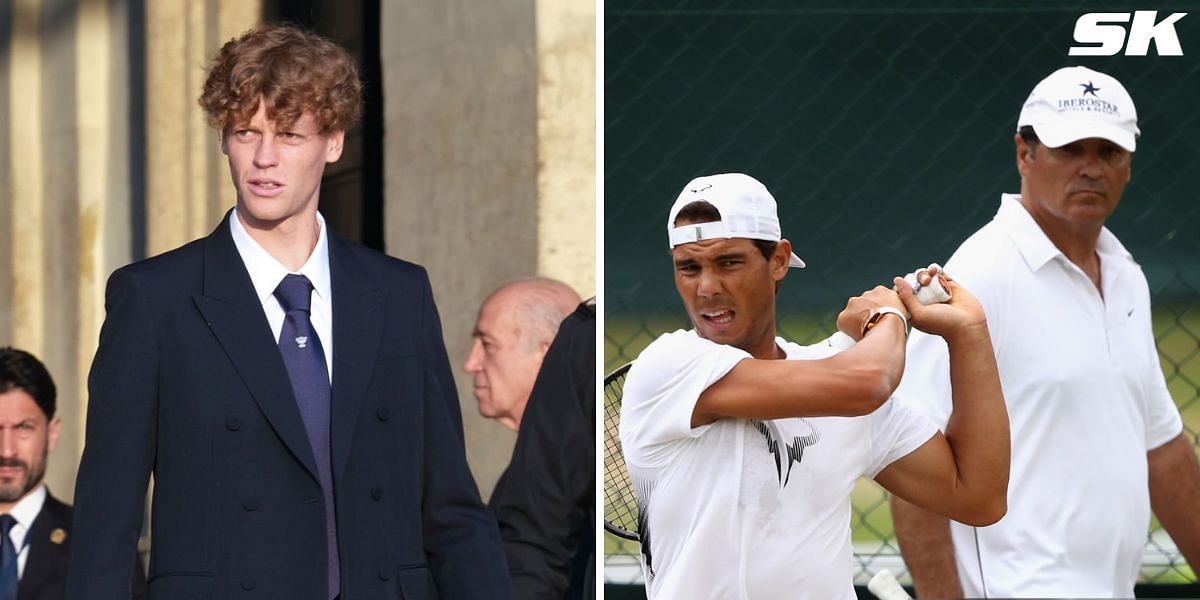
[275,275,341,598]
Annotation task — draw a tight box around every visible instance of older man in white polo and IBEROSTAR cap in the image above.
[893,67,1200,598]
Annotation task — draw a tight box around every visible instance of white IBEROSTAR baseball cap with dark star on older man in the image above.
[1016,67,1141,152]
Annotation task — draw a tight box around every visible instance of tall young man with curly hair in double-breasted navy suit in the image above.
[67,26,510,600]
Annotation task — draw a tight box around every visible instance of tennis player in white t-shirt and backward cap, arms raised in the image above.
[620,174,1009,600]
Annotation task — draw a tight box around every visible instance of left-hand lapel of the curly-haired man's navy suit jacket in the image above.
[192,212,317,479]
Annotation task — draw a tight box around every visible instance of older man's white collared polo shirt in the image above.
[895,194,1182,598]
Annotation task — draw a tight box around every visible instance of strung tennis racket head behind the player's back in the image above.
[604,362,641,541]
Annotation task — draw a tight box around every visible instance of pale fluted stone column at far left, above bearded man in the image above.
[0,0,130,499]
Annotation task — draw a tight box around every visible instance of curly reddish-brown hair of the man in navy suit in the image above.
[200,25,362,133]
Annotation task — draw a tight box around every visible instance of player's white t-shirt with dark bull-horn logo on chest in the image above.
[620,330,937,600]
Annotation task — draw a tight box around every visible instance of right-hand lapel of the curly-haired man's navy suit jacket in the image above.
[329,236,384,479]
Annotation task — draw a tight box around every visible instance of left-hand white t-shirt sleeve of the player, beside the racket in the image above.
[620,330,750,467]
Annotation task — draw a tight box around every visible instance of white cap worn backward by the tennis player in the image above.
[667,173,804,269]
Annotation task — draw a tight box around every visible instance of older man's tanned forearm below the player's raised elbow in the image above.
[892,496,962,598]
